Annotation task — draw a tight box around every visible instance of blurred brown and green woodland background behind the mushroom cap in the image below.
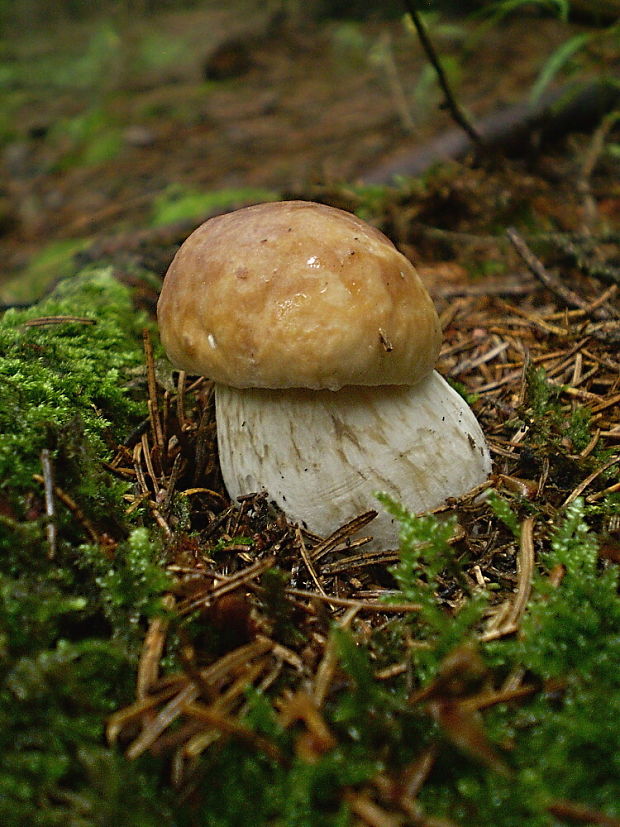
[0,0,620,302]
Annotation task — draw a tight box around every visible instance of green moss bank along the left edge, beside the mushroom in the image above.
[0,270,172,827]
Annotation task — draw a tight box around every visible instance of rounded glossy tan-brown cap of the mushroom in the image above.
[157,201,441,390]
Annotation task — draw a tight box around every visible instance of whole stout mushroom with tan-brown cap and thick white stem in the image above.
[157,201,491,548]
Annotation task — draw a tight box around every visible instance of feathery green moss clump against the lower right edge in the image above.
[477,500,620,824]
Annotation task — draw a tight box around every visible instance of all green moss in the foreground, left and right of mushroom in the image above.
[0,270,620,827]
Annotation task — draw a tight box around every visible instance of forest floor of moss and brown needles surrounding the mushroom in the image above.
[0,0,620,827]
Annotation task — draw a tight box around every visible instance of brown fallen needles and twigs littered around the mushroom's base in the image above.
[108,199,620,826]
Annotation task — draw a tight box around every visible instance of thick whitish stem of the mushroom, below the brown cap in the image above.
[216,371,491,548]
